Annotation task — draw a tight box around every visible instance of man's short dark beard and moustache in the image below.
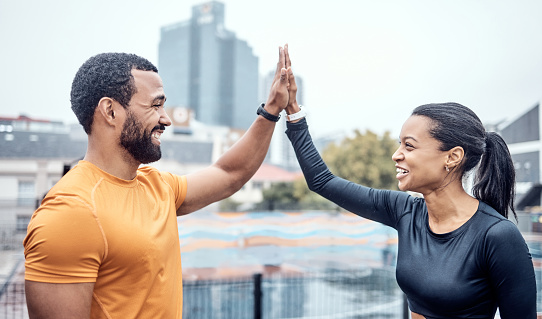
[120,111,164,164]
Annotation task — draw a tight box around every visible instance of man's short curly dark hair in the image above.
[71,53,158,134]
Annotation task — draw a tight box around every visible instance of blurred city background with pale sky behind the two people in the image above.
[0,0,542,318]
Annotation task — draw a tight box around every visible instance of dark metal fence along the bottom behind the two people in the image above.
[0,268,408,319]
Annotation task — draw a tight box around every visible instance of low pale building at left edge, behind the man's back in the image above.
[0,116,86,231]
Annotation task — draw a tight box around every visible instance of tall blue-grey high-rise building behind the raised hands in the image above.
[158,1,260,129]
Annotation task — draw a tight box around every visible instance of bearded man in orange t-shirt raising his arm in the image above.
[24,47,291,319]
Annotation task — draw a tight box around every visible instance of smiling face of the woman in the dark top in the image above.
[392,115,448,195]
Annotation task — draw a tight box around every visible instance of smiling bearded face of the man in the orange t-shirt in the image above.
[120,70,171,164]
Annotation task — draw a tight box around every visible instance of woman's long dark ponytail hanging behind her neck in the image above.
[472,132,517,220]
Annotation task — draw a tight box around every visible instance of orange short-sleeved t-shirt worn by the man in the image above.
[24,161,187,319]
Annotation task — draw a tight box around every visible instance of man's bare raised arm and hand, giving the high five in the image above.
[177,47,288,215]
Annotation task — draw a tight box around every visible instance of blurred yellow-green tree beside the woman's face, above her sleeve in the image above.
[322,130,397,189]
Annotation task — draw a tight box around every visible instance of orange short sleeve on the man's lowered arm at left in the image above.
[24,196,107,283]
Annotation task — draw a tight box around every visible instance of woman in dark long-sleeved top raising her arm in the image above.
[286,51,536,319]
